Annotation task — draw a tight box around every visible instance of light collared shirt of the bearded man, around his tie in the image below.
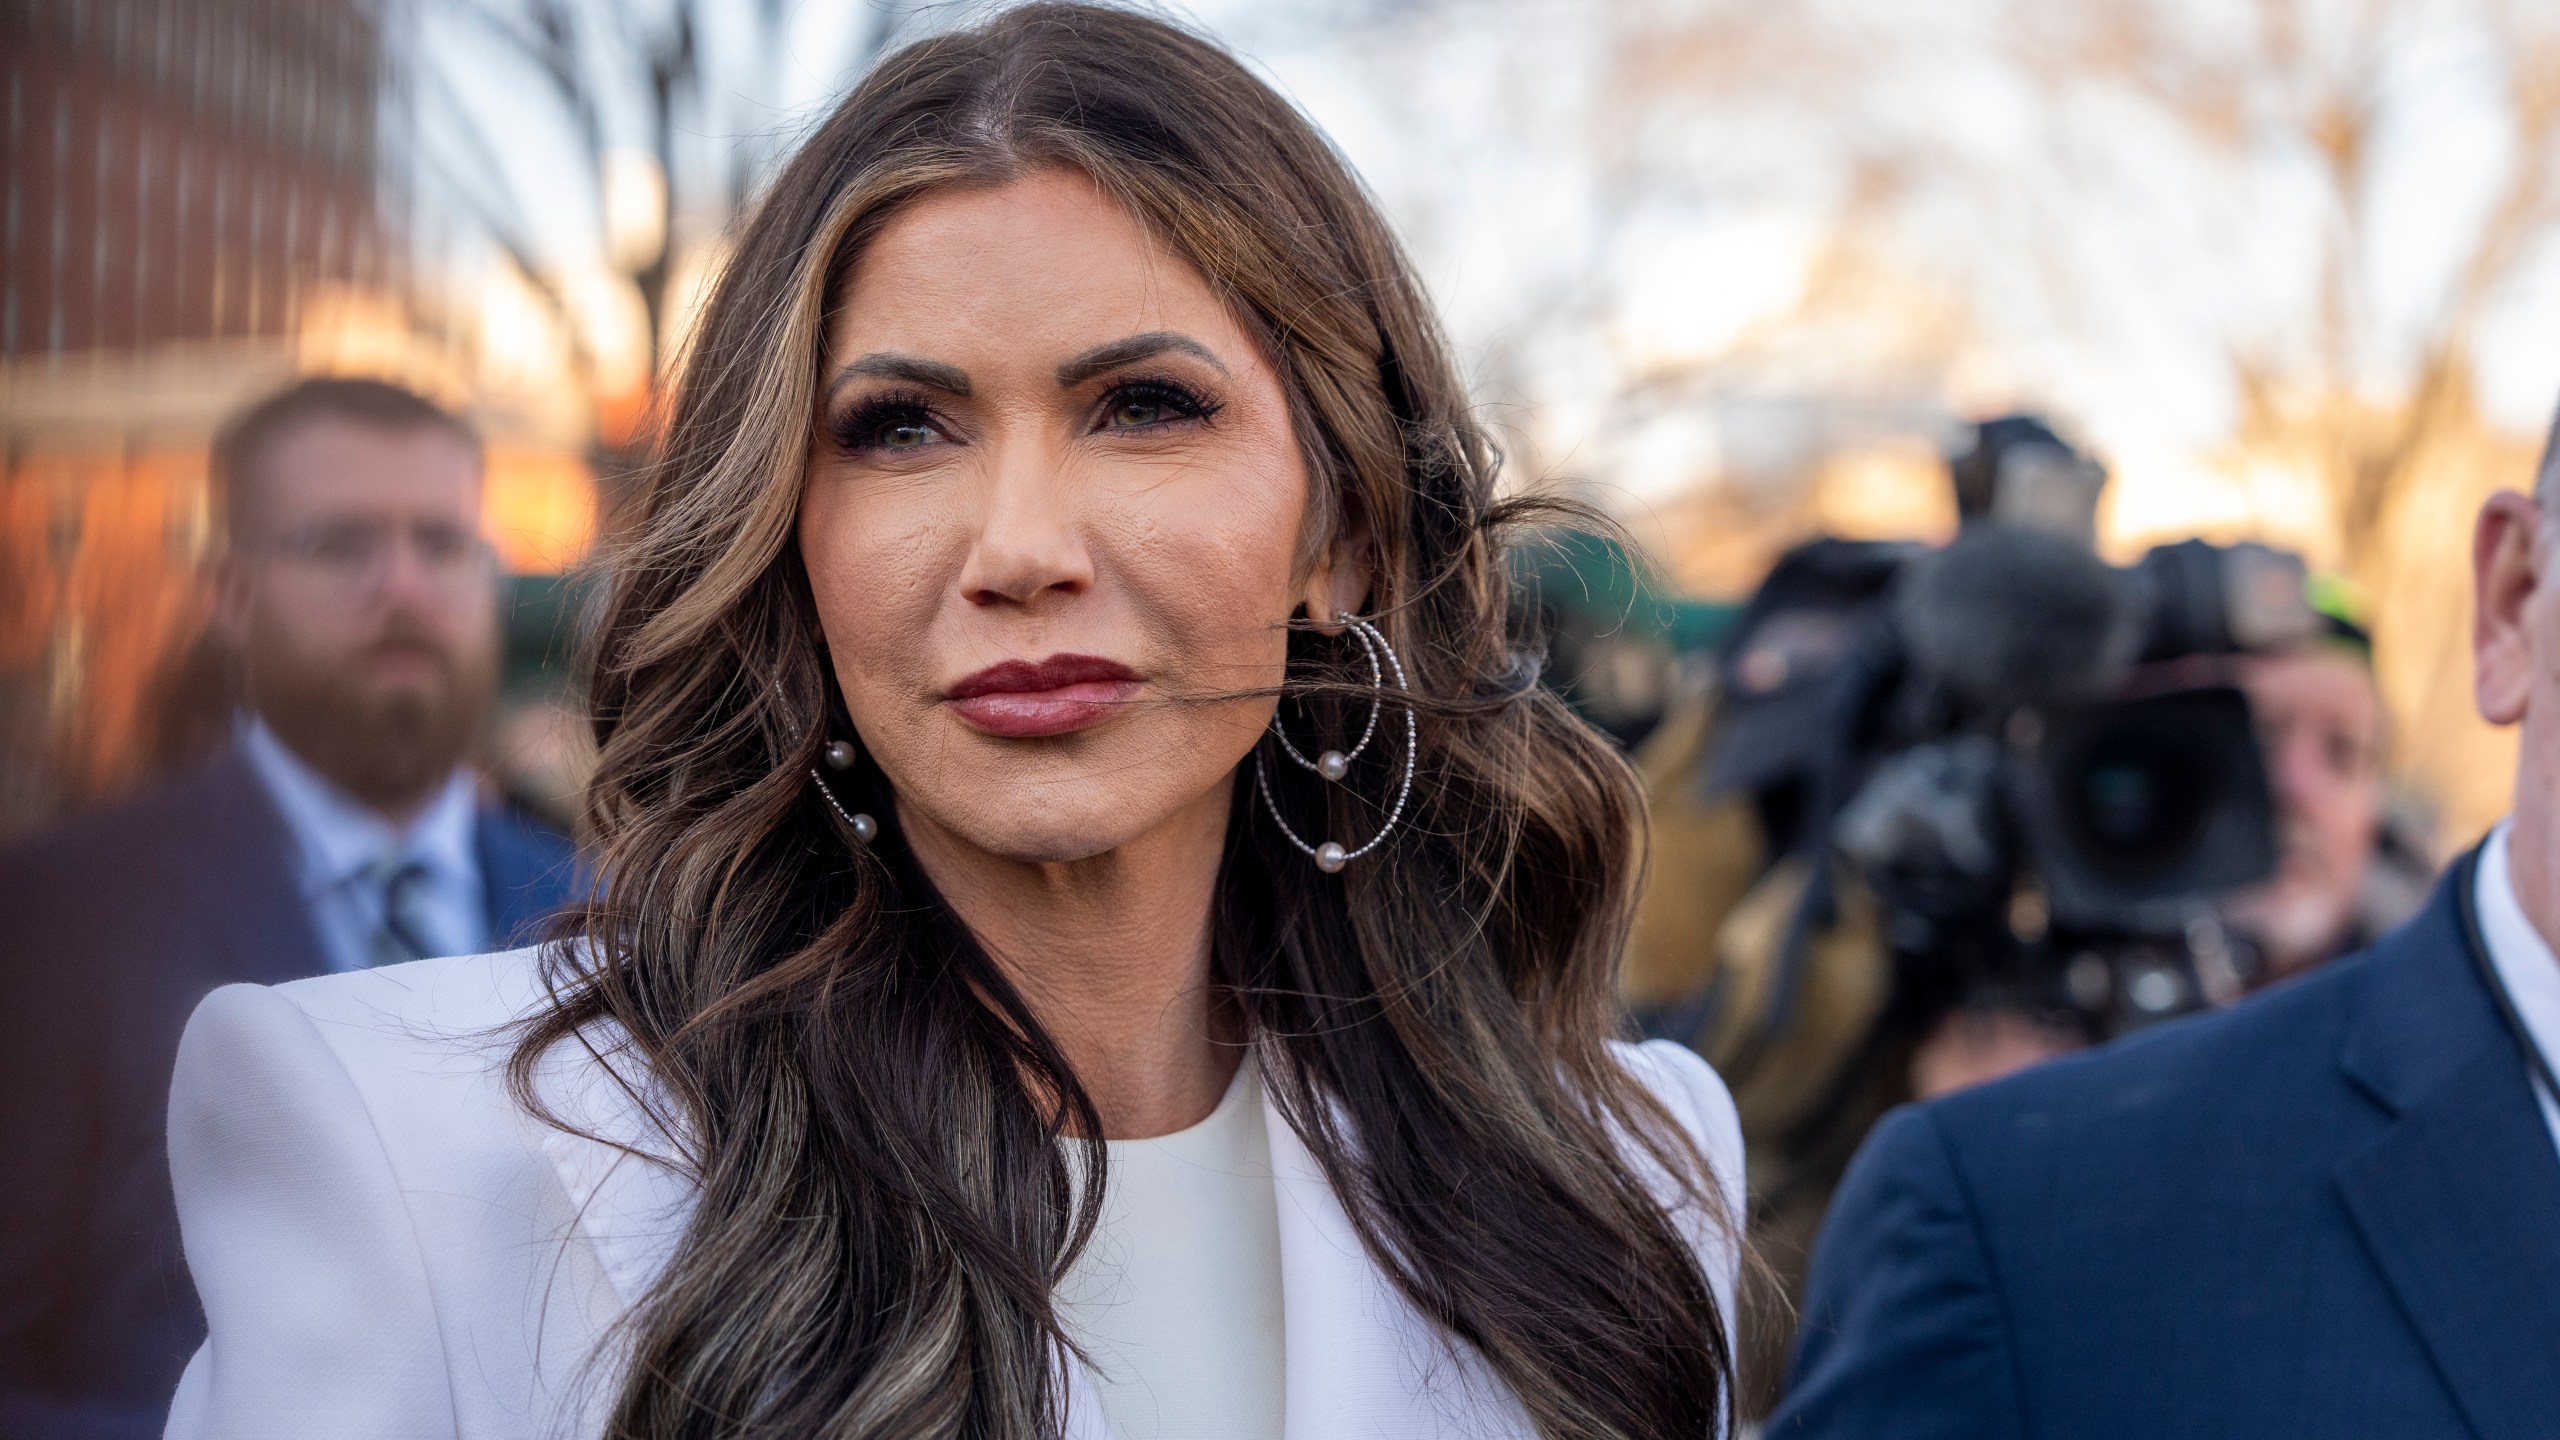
[241,720,489,971]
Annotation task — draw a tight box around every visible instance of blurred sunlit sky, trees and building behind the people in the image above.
[0,0,2560,843]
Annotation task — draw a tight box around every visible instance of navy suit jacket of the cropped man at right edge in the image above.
[1769,866,2560,1440]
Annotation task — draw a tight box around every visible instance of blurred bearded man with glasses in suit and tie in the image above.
[0,379,576,1437]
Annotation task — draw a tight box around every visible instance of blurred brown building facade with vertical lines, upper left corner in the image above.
[0,0,389,363]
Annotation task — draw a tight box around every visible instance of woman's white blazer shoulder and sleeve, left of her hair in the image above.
[169,951,689,1435]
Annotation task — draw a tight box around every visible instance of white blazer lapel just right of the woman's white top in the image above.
[1262,1086,1536,1440]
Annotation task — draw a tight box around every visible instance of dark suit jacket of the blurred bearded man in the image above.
[0,751,573,1440]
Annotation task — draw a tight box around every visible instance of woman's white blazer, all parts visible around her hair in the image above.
[169,951,1743,1440]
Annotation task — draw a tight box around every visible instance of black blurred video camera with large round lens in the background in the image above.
[1708,418,2319,1038]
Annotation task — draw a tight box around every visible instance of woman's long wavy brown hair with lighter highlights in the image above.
[512,5,1733,1440]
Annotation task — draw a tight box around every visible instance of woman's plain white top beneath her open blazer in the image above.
[1057,1058,1288,1440]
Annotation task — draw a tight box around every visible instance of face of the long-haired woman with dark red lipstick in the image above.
[799,172,1359,861]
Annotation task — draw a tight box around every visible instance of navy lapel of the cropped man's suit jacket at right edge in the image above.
[2337,881,2560,1440]
